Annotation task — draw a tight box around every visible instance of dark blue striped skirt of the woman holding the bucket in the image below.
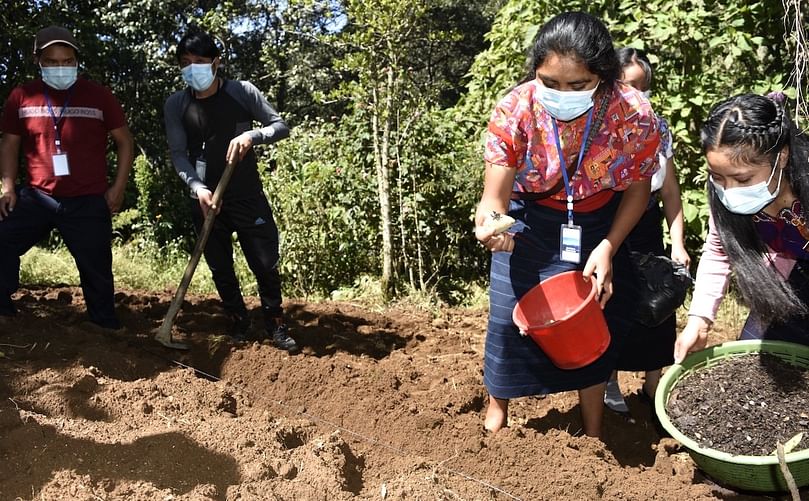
[483,193,637,399]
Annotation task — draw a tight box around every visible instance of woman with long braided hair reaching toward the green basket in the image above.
[674,94,809,362]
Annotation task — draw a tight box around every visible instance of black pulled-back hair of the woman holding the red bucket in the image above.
[525,12,621,87]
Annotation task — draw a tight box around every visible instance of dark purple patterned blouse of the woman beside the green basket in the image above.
[753,200,809,259]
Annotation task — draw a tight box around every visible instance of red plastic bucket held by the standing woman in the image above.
[512,271,610,369]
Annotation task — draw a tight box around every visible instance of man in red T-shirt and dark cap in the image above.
[0,26,134,329]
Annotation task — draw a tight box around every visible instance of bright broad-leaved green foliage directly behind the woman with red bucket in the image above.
[456,0,791,253]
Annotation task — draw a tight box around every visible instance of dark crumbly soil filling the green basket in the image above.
[666,354,809,456]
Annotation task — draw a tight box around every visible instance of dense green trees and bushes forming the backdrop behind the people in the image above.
[0,0,804,298]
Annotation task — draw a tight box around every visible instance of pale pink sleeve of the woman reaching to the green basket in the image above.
[688,217,730,322]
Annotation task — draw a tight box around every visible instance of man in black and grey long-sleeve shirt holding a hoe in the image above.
[164,32,298,352]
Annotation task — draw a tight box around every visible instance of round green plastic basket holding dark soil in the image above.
[655,340,809,492]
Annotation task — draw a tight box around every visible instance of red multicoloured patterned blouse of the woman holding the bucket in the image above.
[483,80,661,200]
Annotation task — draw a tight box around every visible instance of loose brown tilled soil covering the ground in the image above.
[0,287,796,501]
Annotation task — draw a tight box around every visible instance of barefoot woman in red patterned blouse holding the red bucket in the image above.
[475,12,660,436]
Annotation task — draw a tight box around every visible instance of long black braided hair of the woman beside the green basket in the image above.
[700,94,809,322]
